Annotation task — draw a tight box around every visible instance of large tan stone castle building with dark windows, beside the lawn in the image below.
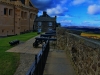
[0,0,38,36]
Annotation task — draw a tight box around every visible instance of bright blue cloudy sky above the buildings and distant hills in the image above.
[31,0,100,27]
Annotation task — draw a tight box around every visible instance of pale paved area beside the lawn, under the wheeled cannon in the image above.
[7,36,42,54]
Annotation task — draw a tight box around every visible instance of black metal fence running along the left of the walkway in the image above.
[26,40,50,75]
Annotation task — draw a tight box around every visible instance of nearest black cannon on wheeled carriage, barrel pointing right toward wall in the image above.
[33,37,57,48]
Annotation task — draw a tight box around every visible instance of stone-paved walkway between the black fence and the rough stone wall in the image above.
[43,50,75,75]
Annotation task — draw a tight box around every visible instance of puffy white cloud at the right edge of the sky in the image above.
[88,4,100,15]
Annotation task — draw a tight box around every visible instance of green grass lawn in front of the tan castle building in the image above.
[0,32,37,75]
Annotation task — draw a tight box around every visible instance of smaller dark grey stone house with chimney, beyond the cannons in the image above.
[34,11,57,32]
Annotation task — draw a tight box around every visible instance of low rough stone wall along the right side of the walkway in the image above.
[56,28,100,75]
